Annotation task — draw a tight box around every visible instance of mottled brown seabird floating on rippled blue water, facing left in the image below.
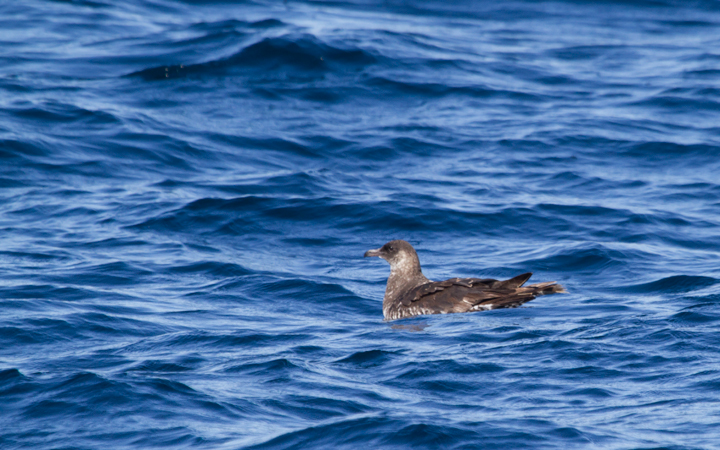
[365,240,567,320]
